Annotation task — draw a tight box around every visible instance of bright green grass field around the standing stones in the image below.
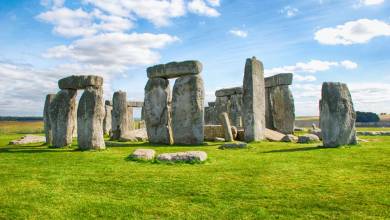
[0,122,390,219]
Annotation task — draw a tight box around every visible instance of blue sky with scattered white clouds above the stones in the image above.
[0,0,390,115]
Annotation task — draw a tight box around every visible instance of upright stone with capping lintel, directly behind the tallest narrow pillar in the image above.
[265,73,295,134]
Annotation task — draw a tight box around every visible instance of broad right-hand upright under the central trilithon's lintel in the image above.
[172,75,204,144]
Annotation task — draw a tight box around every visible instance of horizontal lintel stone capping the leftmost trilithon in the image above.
[58,75,103,89]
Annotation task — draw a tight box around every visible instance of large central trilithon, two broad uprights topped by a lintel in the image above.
[143,61,204,145]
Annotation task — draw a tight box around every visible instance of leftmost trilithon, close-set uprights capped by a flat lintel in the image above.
[44,75,105,150]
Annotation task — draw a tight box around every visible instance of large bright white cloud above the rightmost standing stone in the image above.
[314,19,390,45]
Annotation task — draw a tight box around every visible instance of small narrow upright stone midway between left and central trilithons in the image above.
[111,91,130,140]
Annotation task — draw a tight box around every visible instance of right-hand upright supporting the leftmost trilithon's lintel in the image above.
[77,86,106,150]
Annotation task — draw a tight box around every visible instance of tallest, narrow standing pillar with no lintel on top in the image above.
[242,58,265,142]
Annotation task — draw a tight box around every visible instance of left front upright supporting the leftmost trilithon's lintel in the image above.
[49,89,77,148]
